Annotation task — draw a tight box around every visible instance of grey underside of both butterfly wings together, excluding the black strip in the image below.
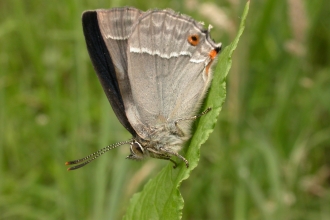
[98,10,217,139]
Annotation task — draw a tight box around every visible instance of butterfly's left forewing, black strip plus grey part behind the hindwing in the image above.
[82,8,141,135]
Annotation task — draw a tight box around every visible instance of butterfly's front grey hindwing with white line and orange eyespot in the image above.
[124,11,216,138]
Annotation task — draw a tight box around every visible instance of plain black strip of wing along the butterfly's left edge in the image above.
[82,11,136,136]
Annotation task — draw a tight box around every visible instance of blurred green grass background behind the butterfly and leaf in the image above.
[0,0,330,220]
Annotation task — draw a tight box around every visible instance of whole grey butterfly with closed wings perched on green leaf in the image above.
[66,7,221,170]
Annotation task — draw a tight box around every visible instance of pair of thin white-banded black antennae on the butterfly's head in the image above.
[65,140,132,171]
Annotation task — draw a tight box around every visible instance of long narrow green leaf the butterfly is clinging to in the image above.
[124,1,249,220]
